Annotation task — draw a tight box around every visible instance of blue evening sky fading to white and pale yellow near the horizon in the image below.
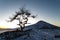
[0,0,60,28]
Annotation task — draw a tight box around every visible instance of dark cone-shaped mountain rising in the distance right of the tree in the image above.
[27,21,60,29]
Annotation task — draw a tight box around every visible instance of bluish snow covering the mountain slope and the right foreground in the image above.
[0,22,60,40]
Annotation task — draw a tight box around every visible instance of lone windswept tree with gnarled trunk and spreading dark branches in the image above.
[9,8,36,31]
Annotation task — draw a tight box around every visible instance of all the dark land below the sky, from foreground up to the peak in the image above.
[0,21,60,40]
